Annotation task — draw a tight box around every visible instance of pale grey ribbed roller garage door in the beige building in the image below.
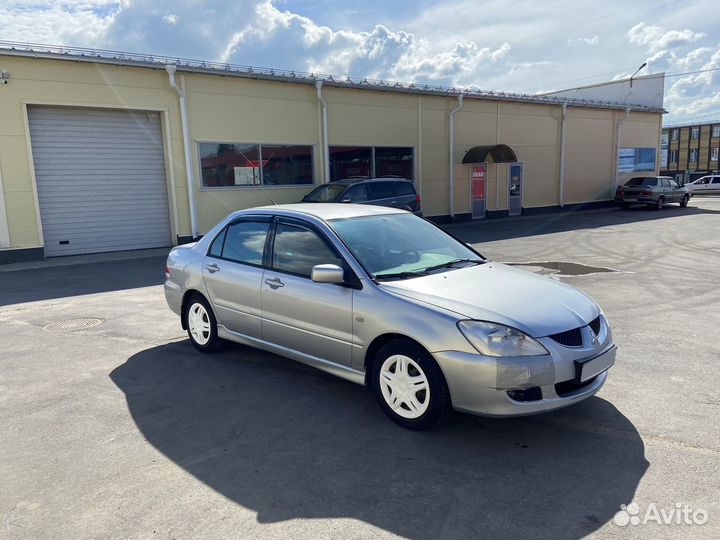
[28,106,171,257]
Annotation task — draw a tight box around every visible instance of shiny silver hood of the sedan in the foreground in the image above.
[380,262,600,337]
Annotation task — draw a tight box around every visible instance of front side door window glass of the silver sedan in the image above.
[273,223,342,277]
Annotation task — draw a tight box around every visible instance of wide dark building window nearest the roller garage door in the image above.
[199,143,313,187]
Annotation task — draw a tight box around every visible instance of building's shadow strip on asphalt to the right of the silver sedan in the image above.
[444,205,720,244]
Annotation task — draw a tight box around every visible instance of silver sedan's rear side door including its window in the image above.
[203,216,272,338]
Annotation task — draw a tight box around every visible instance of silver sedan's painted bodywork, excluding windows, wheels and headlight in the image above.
[165,204,616,416]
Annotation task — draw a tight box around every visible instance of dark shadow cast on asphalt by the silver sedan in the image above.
[110,341,648,539]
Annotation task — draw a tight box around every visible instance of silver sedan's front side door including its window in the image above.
[261,218,353,365]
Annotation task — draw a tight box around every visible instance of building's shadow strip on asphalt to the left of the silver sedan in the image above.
[0,255,167,307]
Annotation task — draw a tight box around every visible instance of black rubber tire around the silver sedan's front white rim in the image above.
[370,339,453,431]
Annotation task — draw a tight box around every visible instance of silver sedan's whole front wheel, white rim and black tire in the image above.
[370,339,452,430]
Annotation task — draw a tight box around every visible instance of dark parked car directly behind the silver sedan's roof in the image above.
[302,178,422,215]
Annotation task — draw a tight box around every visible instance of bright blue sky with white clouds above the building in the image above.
[0,0,720,123]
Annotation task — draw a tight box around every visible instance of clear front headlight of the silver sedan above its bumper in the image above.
[458,321,550,356]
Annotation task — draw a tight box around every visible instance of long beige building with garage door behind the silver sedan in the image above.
[0,43,664,262]
